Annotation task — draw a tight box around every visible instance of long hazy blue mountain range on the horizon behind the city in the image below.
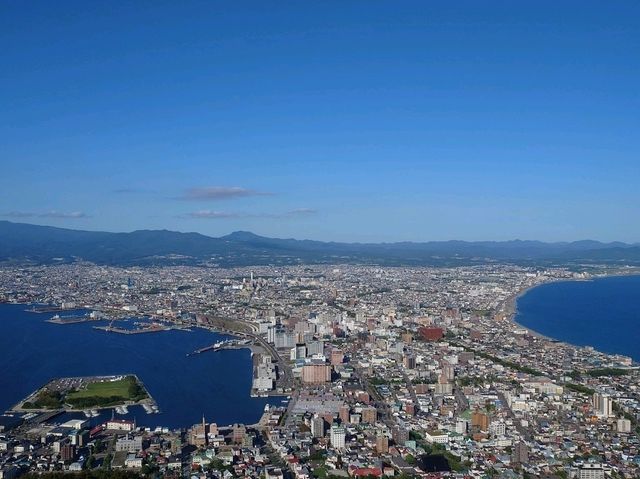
[0,221,640,266]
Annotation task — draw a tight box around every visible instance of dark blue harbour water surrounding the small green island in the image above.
[0,304,282,429]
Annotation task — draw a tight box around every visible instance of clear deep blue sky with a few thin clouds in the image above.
[0,0,640,242]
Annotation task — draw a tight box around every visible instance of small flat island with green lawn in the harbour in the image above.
[14,374,155,411]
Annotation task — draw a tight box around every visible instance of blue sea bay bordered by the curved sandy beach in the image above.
[515,276,640,361]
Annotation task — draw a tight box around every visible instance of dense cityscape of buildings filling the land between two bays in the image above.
[0,263,640,479]
